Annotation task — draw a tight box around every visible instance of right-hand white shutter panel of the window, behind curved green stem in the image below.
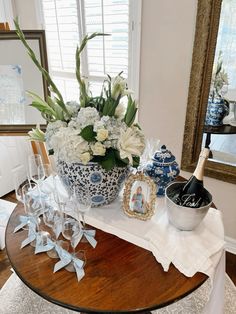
[84,0,129,77]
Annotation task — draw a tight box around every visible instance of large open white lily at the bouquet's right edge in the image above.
[117,127,145,165]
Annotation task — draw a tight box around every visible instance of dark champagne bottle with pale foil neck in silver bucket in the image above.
[176,148,210,208]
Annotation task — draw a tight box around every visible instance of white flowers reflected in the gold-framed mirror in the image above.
[210,51,229,99]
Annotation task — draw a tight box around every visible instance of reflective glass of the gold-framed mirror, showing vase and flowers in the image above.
[202,0,236,166]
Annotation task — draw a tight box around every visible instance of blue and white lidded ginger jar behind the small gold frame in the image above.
[144,145,180,196]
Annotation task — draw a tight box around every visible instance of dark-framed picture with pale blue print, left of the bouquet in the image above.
[0,30,48,135]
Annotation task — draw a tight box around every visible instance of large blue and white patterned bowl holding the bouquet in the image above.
[57,160,130,207]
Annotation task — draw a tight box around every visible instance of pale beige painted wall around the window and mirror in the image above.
[5,0,236,239]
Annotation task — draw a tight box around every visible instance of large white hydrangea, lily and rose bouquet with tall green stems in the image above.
[14,20,145,170]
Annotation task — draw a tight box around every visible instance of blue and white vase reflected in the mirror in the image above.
[205,97,229,126]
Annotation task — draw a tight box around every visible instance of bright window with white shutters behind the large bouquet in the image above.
[41,0,141,101]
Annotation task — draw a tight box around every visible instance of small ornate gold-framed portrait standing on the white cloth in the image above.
[123,172,156,220]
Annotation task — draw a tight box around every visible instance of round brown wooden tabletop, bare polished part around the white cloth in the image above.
[6,205,207,313]
